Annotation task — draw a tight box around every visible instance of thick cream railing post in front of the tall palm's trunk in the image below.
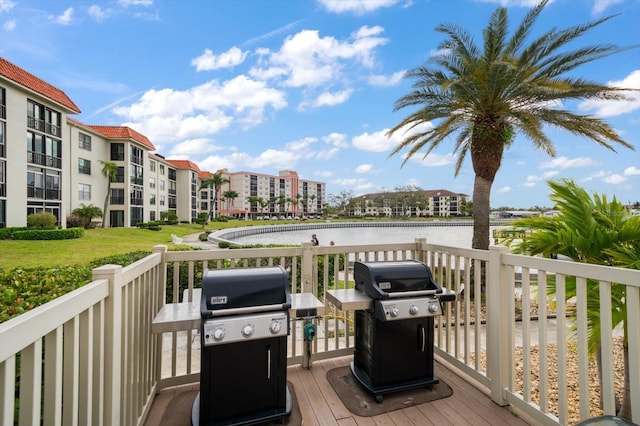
[486,246,513,405]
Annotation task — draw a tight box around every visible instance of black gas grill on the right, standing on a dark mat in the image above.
[351,260,455,402]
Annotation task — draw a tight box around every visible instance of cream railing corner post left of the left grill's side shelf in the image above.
[93,265,122,425]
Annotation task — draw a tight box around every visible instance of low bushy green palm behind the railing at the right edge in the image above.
[507,179,640,419]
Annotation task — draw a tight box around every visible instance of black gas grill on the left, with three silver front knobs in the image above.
[191,267,292,426]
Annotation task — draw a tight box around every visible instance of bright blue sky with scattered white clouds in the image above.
[0,0,640,208]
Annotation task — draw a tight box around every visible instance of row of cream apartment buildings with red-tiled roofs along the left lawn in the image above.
[0,58,326,227]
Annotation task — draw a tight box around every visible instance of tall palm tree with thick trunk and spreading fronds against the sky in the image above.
[387,0,633,250]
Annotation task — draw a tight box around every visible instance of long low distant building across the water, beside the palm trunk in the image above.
[349,189,469,217]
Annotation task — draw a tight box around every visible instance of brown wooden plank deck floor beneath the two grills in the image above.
[146,356,533,426]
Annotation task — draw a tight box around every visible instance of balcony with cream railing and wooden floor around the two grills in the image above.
[0,240,640,426]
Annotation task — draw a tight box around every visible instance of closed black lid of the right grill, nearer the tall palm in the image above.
[353,260,442,299]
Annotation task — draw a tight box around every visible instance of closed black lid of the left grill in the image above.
[200,266,291,318]
